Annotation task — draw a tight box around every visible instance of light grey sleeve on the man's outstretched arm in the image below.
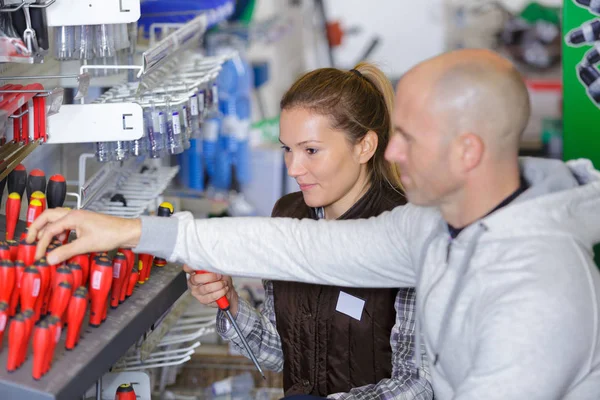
[134,206,439,287]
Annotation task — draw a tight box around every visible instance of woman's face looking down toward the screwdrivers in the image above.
[279,108,370,212]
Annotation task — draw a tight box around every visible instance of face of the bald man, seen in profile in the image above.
[385,75,460,206]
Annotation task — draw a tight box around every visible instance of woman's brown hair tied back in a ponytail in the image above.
[280,62,402,188]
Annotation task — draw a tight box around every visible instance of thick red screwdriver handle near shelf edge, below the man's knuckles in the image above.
[90,256,113,327]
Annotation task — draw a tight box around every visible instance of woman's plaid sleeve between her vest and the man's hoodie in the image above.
[329,288,433,400]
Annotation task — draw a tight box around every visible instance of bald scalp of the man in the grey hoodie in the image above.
[398,49,530,157]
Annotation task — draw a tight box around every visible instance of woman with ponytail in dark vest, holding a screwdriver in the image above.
[189,63,433,399]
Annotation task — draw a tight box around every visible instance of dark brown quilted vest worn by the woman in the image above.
[273,185,406,397]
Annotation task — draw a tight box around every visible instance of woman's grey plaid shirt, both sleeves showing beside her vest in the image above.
[217,281,433,400]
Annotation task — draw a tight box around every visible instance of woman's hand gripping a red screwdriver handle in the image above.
[183,265,238,317]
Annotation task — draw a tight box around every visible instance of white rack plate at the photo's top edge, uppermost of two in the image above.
[46,0,141,26]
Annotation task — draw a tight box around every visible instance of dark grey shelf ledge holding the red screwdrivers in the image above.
[0,264,187,400]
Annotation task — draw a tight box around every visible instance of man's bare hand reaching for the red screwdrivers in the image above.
[26,208,142,265]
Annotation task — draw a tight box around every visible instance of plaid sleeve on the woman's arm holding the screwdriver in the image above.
[217,281,283,372]
